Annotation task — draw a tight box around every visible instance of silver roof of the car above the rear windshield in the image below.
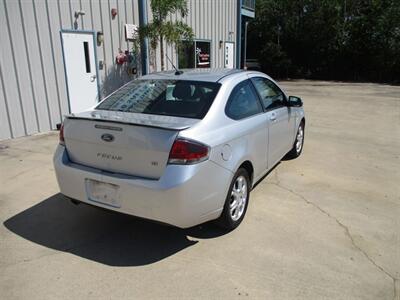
[141,68,245,82]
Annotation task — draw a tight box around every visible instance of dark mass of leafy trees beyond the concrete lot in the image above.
[248,0,400,82]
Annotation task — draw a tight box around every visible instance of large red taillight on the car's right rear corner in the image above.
[168,139,210,165]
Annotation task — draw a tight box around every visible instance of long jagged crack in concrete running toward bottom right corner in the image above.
[270,171,400,300]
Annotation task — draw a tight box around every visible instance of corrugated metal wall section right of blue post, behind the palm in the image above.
[147,0,237,71]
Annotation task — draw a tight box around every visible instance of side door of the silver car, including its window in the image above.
[251,77,294,168]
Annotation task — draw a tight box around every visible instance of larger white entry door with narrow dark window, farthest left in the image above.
[61,31,98,113]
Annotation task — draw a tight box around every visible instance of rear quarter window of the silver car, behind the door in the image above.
[225,80,262,120]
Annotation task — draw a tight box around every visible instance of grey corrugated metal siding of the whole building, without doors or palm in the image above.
[0,0,237,140]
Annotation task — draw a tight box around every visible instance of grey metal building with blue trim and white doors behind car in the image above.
[0,0,255,140]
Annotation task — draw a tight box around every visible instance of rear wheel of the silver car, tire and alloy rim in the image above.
[217,168,250,230]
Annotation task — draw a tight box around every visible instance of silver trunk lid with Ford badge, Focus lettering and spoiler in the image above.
[64,111,199,179]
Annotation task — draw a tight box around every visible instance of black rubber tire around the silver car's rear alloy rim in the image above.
[217,168,251,230]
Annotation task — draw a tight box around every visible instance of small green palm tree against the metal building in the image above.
[139,0,194,71]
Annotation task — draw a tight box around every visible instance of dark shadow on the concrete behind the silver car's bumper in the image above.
[4,194,227,266]
